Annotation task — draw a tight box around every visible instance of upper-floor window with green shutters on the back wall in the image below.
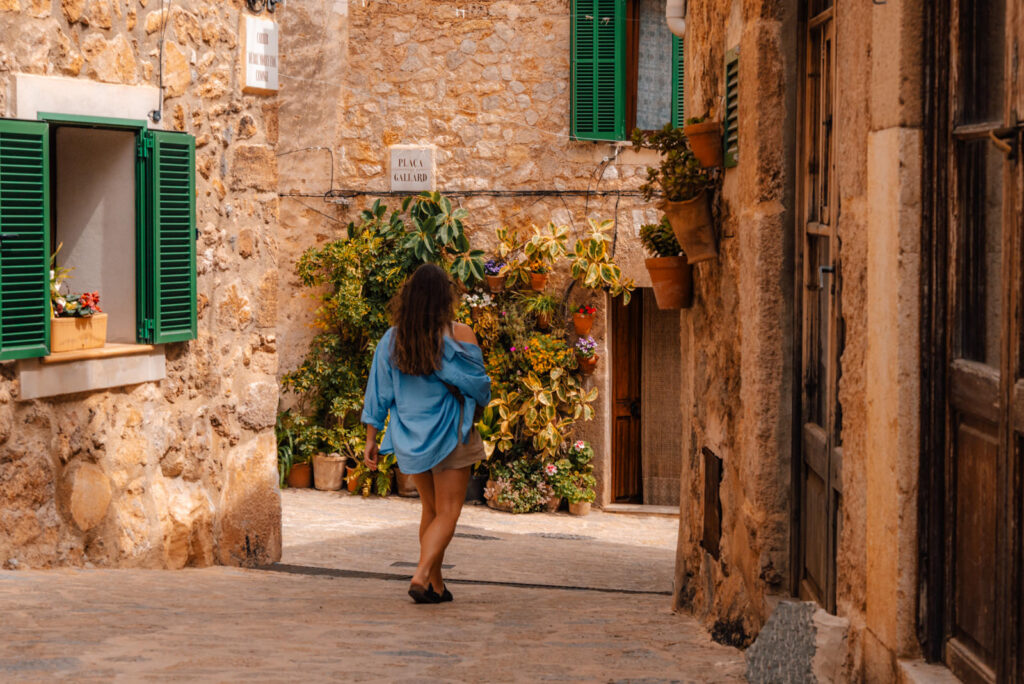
[570,0,683,140]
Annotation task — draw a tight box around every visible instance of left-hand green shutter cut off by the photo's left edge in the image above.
[0,119,50,359]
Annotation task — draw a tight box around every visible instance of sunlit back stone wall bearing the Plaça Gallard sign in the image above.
[279,0,684,503]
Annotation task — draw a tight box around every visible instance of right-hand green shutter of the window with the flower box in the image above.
[145,131,198,344]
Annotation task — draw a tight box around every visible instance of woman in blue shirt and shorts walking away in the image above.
[362,264,490,603]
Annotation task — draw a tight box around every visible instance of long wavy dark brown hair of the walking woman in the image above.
[391,263,457,376]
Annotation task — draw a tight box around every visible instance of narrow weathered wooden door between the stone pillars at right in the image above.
[793,0,842,612]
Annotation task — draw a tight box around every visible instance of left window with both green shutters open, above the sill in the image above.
[0,115,197,359]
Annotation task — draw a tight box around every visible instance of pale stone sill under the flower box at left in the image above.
[17,344,167,401]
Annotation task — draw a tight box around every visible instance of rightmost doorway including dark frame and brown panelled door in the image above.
[920,0,1024,682]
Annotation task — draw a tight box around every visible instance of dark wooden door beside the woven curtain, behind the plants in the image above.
[611,290,643,504]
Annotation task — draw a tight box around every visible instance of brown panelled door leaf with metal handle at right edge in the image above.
[940,0,1024,682]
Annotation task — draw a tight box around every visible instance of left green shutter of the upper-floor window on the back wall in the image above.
[570,0,626,140]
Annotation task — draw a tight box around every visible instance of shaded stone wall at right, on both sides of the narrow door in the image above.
[677,0,923,681]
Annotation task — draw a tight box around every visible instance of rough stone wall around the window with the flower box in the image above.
[0,0,281,567]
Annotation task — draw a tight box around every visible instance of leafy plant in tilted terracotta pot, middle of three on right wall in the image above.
[633,124,717,263]
